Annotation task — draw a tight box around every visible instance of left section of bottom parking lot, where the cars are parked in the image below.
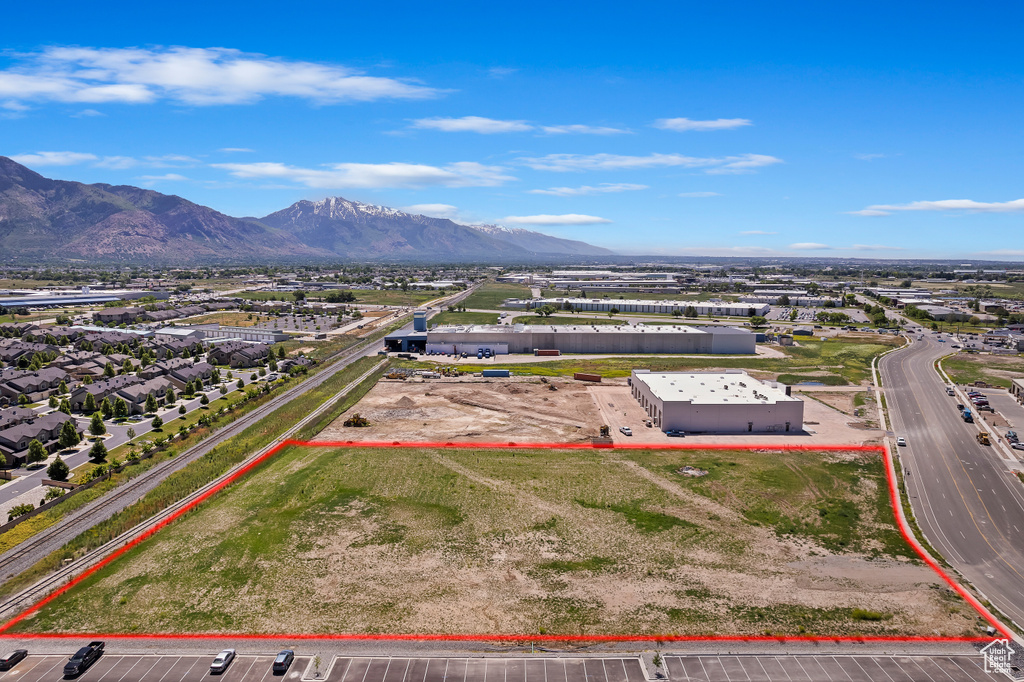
[0,653,309,682]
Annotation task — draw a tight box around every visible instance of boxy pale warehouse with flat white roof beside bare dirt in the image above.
[630,370,804,433]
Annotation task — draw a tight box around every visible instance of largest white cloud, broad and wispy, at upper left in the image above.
[0,47,440,105]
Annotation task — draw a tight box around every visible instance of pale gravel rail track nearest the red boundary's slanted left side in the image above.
[0,356,380,619]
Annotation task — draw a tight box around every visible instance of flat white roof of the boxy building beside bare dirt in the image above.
[633,372,800,404]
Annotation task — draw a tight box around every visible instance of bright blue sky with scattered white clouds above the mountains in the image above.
[0,2,1024,260]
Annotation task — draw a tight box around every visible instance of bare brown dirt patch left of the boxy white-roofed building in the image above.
[319,377,601,442]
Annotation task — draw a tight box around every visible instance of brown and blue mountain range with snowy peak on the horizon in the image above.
[0,157,612,265]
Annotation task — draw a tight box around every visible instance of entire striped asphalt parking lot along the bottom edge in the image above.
[0,654,992,682]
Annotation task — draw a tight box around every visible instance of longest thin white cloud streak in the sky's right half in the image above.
[519,154,782,174]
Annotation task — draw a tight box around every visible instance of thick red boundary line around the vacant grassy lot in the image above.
[0,440,1013,643]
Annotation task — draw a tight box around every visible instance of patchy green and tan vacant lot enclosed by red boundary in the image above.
[18,449,975,635]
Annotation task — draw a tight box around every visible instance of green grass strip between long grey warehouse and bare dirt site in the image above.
[401,337,900,386]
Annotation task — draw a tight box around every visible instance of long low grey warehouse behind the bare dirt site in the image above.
[384,324,756,355]
